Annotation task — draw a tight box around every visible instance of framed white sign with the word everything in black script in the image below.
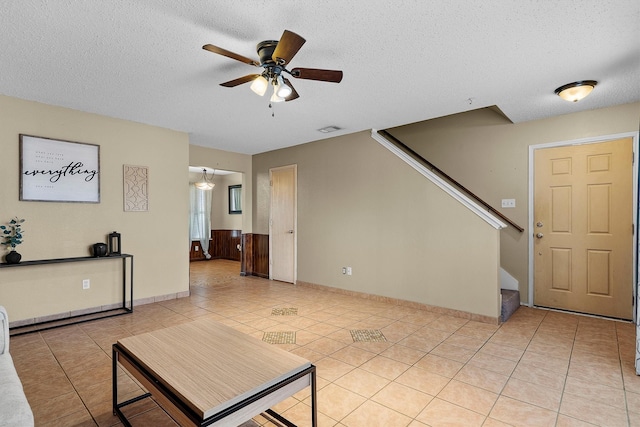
[20,134,100,203]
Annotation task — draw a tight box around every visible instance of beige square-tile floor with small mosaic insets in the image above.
[11,261,640,427]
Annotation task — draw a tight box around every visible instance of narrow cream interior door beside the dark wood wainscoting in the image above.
[269,165,297,283]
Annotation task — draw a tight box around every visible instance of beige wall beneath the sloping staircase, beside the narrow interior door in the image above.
[253,132,500,318]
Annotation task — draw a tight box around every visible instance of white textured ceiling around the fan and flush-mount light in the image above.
[0,0,640,154]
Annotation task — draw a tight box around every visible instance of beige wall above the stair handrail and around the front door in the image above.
[389,103,640,302]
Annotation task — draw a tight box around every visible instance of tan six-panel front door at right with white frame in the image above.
[533,138,633,319]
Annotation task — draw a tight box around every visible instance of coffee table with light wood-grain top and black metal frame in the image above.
[112,319,317,427]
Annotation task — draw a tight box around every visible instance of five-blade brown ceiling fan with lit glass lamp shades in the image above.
[202,30,342,102]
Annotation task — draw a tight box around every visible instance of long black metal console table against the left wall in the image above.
[0,254,133,336]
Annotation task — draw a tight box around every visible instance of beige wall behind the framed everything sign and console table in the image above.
[0,96,189,321]
